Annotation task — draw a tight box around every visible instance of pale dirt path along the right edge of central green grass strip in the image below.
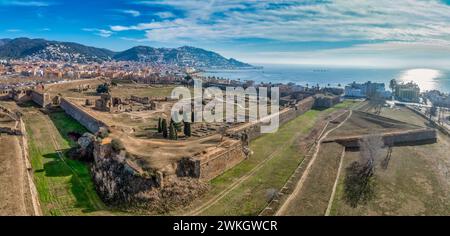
[276,110,352,216]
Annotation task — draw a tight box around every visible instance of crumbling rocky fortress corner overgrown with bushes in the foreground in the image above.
[91,140,208,208]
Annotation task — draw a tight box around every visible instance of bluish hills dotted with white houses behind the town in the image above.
[0,38,253,68]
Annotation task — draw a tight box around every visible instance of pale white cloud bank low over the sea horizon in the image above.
[232,42,450,68]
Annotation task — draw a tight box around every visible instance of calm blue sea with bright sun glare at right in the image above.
[204,65,450,93]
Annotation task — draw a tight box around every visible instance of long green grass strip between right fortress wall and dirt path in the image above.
[182,101,354,215]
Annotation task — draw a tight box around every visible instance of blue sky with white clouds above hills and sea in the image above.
[0,0,450,68]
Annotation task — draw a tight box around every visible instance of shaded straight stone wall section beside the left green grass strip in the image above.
[60,98,106,133]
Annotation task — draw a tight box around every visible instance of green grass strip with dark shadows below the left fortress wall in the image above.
[24,107,121,215]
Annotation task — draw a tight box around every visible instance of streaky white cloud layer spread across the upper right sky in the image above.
[111,0,450,42]
